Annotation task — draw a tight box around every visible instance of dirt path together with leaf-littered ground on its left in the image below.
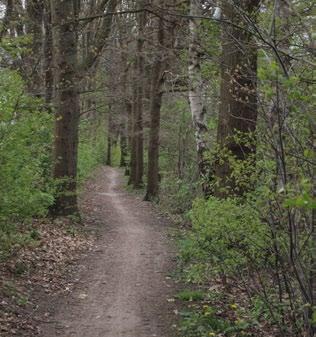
[0,167,175,337]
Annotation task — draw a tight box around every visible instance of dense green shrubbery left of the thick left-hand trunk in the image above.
[0,70,54,255]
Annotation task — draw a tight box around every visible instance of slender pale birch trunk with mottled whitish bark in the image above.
[188,0,210,195]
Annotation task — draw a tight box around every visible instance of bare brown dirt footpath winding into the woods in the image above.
[41,167,175,337]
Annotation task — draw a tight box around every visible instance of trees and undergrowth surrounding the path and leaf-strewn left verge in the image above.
[0,0,316,337]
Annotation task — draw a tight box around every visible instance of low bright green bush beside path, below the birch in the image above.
[180,197,267,277]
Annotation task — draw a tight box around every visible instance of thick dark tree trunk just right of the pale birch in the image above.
[215,0,260,197]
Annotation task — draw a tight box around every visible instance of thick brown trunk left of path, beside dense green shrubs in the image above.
[51,0,80,215]
